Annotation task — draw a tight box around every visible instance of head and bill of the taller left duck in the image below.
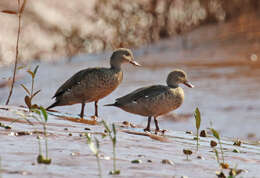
[110,48,141,69]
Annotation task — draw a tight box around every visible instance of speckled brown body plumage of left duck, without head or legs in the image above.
[54,68,123,106]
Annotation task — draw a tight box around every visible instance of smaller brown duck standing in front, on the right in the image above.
[105,69,193,132]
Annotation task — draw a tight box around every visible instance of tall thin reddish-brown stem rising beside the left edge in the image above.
[5,0,22,105]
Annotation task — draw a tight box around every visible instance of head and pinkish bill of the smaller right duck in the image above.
[166,69,194,88]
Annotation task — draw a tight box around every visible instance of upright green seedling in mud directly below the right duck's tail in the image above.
[102,120,120,175]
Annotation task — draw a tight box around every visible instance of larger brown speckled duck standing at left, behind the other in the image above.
[47,48,140,118]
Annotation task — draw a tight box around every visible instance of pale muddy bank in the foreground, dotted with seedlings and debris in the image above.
[0,106,260,178]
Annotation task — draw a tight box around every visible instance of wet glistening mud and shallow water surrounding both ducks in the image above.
[0,14,260,177]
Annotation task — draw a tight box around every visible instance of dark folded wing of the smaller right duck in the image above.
[116,85,168,105]
